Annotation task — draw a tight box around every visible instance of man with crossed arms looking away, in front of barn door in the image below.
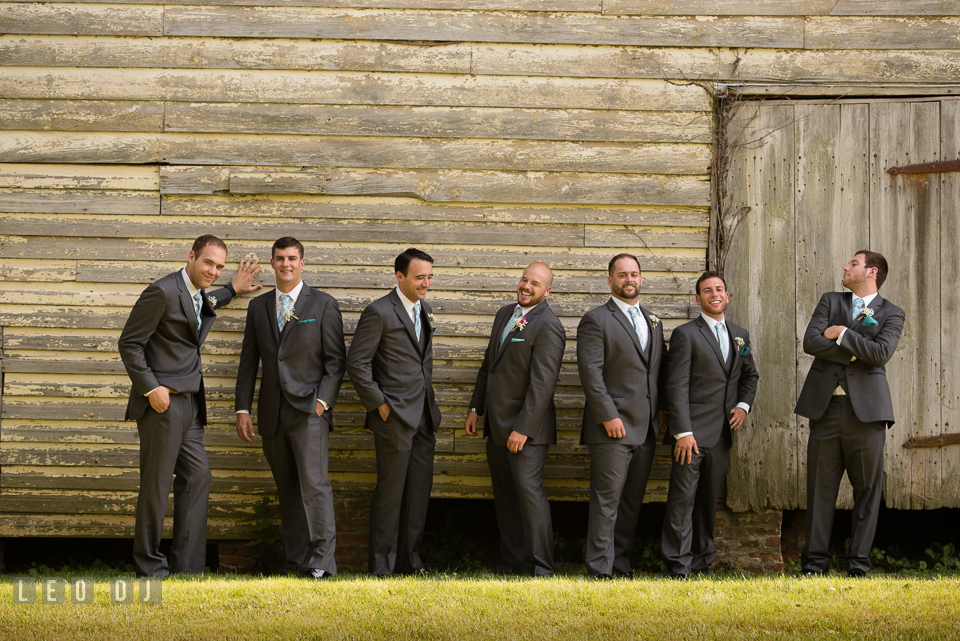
[794,249,906,577]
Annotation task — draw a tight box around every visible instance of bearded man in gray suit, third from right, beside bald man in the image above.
[577,254,667,579]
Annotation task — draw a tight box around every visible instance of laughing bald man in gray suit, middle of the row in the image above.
[464,263,567,576]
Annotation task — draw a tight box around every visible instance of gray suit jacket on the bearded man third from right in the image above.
[577,299,667,445]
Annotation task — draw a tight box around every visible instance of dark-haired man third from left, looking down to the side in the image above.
[347,248,440,576]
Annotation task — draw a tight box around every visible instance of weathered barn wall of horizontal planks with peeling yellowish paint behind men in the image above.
[0,0,960,538]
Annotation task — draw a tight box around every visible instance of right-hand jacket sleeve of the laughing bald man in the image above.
[513,320,567,438]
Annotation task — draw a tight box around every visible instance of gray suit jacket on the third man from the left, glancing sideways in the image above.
[347,289,440,431]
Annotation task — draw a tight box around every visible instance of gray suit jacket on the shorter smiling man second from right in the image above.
[666,317,760,447]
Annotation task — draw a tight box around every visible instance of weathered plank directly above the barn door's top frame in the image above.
[730,48,960,84]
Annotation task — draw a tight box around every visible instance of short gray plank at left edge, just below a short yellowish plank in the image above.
[0,189,160,216]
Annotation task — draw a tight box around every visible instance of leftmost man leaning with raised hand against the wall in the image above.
[117,235,262,577]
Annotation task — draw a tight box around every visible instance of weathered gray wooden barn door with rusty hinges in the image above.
[726,99,960,510]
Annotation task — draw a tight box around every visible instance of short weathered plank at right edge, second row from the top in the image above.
[804,17,960,49]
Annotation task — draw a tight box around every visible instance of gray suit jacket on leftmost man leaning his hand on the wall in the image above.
[117,271,233,425]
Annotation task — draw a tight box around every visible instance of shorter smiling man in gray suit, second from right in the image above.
[660,271,760,578]
